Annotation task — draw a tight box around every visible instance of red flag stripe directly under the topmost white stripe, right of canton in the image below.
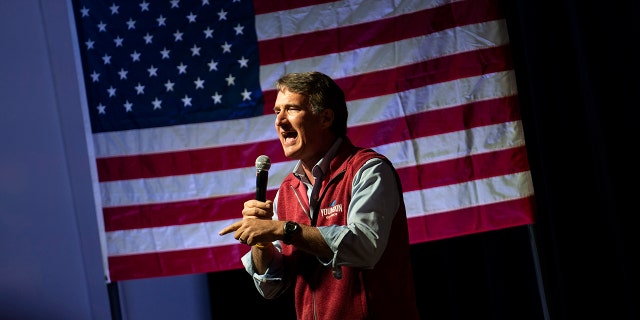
[258,0,501,65]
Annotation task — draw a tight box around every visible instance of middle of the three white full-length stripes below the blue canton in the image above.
[100,121,524,207]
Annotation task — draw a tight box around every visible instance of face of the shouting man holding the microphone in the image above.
[273,89,328,163]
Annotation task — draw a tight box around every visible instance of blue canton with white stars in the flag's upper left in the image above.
[74,0,263,133]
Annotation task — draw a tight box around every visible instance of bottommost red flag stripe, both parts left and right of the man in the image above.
[108,197,535,281]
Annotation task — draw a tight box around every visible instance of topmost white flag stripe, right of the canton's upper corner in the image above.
[255,0,464,41]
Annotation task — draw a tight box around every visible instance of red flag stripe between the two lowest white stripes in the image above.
[103,147,529,231]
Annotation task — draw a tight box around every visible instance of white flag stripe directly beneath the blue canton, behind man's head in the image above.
[93,71,517,158]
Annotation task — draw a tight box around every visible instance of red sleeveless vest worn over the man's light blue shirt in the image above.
[277,139,419,320]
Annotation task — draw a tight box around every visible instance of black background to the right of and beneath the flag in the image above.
[208,0,640,320]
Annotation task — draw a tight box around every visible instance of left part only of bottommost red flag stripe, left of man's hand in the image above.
[108,245,250,281]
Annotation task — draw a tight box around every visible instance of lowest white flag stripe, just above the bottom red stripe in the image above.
[107,172,533,256]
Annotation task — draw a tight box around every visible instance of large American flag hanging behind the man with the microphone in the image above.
[73,0,534,281]
